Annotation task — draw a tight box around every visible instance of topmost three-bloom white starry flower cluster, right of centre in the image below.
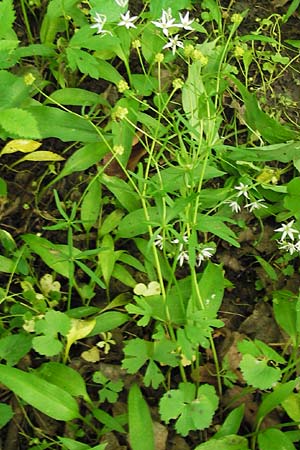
[152,8,194,55]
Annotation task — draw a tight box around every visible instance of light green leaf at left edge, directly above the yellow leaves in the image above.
[0,108,43,139]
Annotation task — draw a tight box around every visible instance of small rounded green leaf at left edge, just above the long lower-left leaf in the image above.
[0,333,32,366]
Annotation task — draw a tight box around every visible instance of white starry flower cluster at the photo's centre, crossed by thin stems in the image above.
[154,233,215,267]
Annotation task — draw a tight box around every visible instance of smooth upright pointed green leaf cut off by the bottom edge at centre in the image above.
[128,384,155,450]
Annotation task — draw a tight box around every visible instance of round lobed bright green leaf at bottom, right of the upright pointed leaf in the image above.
[159,383,219,436]
